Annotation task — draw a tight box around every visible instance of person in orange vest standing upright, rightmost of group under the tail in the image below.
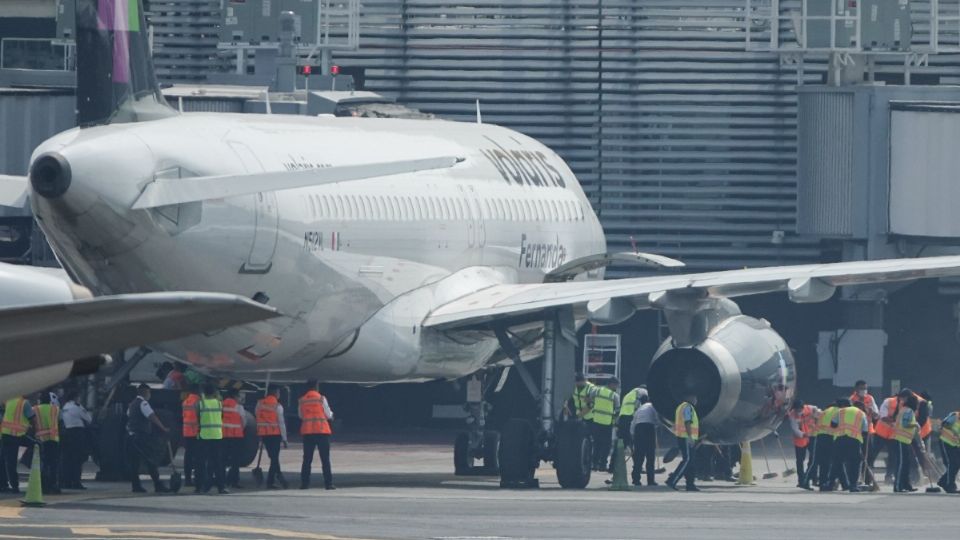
[298,381,337,489]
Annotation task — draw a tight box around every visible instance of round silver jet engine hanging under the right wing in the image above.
[647,315,797,444]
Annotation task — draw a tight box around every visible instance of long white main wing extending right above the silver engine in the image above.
[423,256,960,330]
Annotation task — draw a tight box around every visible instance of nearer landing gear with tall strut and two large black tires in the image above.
[496,308,593,488]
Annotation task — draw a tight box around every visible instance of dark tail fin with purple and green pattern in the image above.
[76,0,177,127]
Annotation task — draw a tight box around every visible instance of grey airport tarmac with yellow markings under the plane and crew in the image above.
[0,433,960,540]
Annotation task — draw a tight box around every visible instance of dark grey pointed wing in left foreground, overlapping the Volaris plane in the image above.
[0,292,279,377]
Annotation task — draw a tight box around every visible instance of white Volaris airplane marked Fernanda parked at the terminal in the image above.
[0,0,960,488]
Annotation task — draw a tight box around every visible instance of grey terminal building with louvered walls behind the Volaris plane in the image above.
[0,0,960,418]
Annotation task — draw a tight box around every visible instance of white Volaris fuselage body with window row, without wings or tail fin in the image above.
[32,114,606,383]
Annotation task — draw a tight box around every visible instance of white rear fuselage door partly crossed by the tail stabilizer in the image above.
[230,141,280,274]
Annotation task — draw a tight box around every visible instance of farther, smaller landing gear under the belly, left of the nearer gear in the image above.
[453,375,500,476]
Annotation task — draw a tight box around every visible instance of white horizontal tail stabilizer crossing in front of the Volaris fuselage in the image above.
[132,156,463,210]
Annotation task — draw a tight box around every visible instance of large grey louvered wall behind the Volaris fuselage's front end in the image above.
[326,0,820,275]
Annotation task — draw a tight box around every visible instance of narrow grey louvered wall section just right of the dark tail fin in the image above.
[146,0,221,83]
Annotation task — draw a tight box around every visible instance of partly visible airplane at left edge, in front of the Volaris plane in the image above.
[0,263,278,401]
